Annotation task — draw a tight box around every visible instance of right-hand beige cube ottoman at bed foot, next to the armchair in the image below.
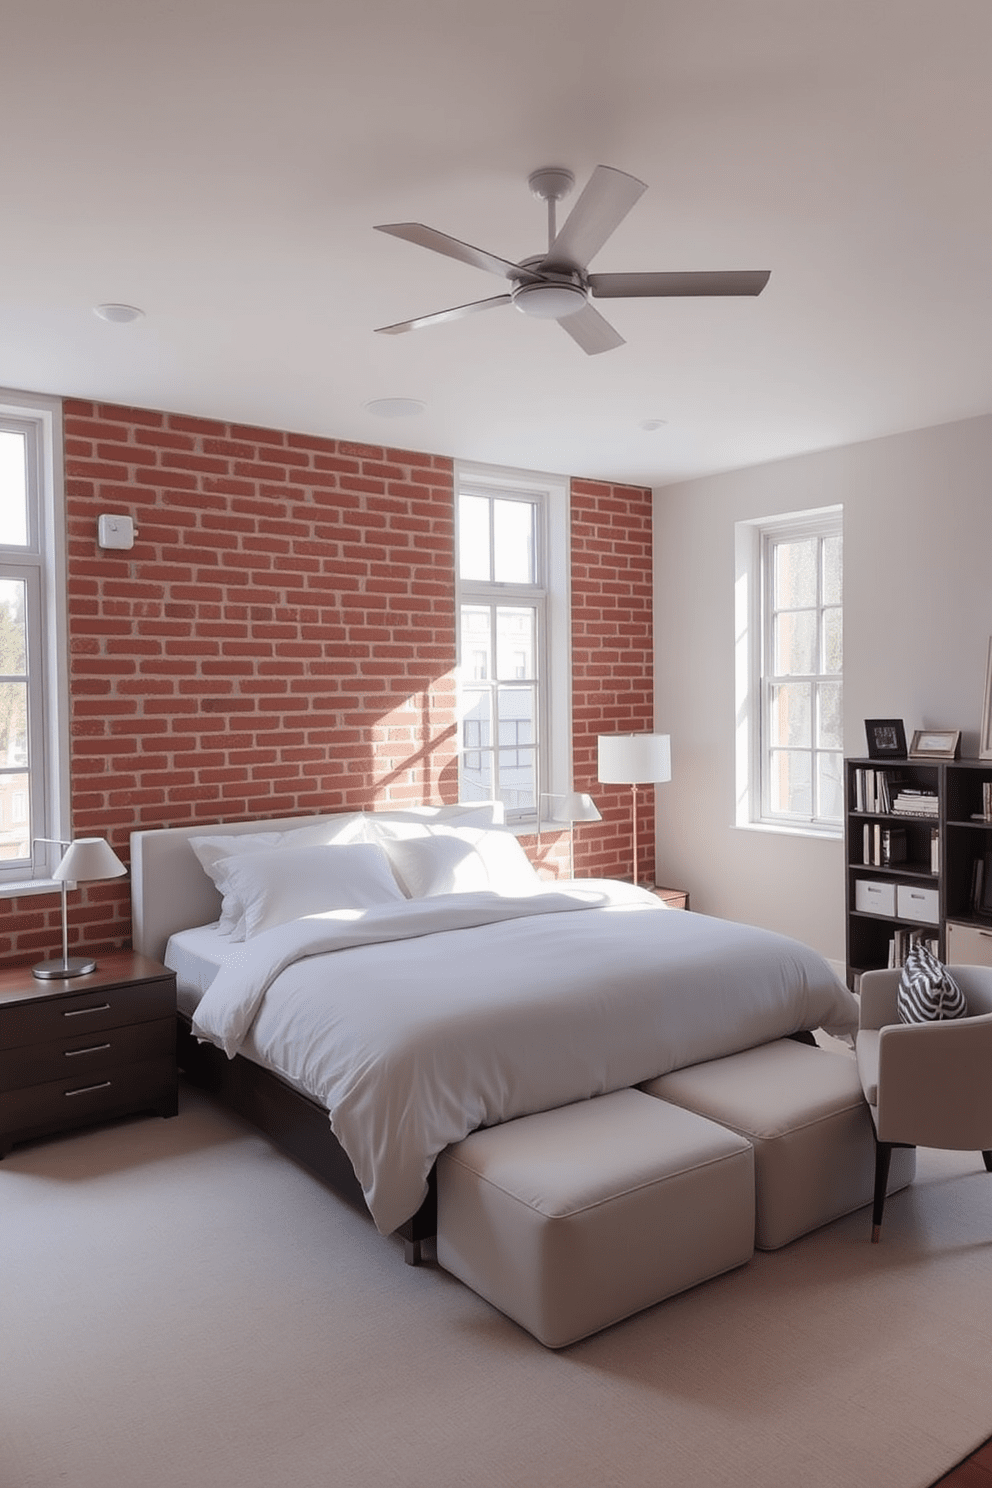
[642,1039,916,1250]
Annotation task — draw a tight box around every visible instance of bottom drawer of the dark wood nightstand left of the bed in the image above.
[0,1058,177,1141]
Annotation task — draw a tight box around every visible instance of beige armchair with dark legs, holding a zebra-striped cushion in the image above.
[857,966,992,1241]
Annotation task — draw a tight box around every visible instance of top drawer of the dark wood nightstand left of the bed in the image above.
[0,976,175,1049]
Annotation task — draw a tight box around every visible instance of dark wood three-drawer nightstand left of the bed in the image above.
[0,951,178,1158]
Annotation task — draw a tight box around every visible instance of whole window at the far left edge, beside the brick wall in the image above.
[0,391,68,890]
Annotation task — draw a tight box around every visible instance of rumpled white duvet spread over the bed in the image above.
[193,881,857,1234]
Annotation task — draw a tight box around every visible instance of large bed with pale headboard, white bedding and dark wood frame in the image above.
[131,805,857,1260]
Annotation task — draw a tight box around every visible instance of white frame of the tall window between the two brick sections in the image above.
[455,461,571,833]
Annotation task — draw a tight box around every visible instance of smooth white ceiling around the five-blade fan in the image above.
[0,0,992,485]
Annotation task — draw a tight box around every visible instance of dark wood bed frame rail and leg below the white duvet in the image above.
[177,1013,437,1266]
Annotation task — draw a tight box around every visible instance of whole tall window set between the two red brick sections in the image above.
[455,467,571,826]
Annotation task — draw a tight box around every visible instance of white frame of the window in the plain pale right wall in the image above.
[735,504,843,839]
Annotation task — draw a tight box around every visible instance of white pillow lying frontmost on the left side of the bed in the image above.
[220,842,403,940]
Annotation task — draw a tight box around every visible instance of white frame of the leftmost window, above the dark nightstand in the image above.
[0,388,70,899]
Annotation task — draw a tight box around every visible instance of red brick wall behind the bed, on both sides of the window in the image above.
[0,400,653,960]
